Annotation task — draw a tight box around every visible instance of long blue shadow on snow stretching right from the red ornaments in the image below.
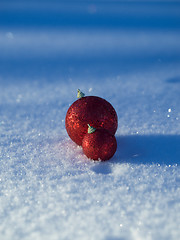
[114,135,180,165]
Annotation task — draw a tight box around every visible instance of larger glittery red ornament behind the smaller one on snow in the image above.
[65,90,118,145]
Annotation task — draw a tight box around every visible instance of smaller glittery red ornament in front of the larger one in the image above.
[82,126,117,161]
